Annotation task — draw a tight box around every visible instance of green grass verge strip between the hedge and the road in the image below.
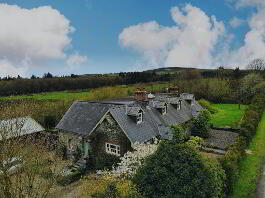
[229,112,265,198]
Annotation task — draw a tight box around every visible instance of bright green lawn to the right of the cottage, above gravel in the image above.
[211,104,247,127]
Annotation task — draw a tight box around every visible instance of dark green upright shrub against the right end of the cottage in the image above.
[191,109,211,138]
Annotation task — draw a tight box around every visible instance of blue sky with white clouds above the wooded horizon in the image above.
[0,0,265,77]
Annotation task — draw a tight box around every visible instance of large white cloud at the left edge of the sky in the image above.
[0,4,74,74]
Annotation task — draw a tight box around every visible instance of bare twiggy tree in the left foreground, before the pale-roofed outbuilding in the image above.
[0,103,61,198]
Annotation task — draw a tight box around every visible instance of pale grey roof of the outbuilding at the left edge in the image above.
[0,117,45,140]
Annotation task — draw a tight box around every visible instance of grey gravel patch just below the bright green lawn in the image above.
[205,129,239,150]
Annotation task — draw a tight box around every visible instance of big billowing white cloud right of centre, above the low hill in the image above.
[119,4,225,67]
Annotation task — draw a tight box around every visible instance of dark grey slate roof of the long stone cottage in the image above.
[56,93,202,143]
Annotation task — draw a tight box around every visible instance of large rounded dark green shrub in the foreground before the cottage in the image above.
[133,142,225,198]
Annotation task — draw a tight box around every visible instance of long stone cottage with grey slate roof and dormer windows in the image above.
[56,90,202,162]
